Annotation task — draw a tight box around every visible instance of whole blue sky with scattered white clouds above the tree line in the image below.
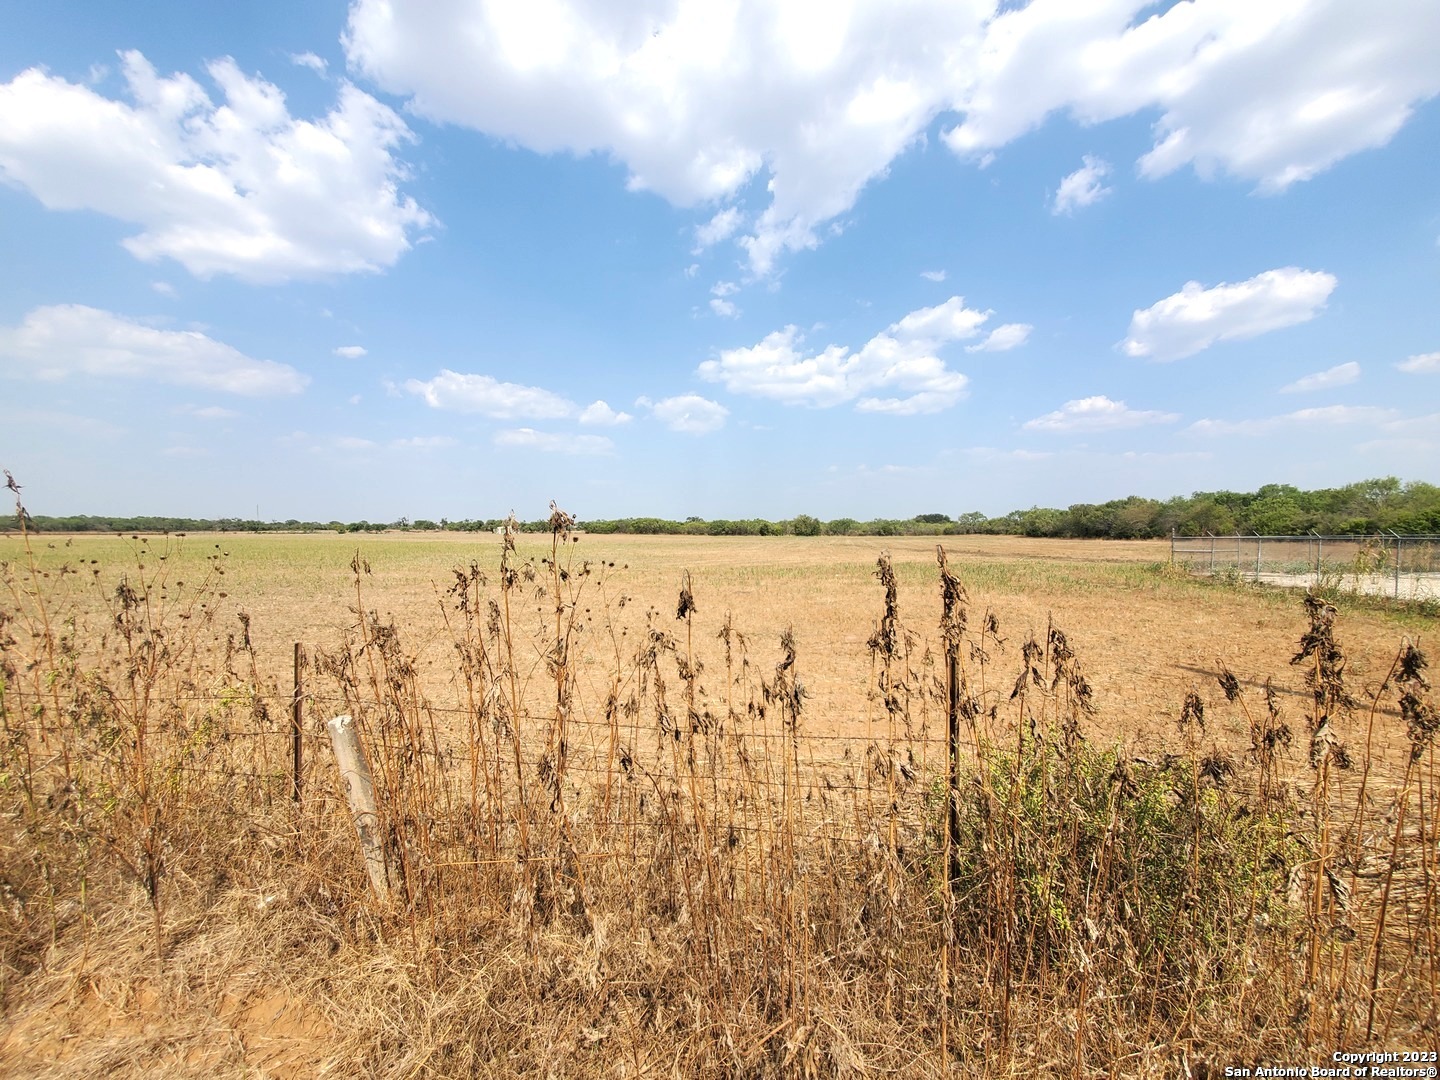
[0,0,1440,521]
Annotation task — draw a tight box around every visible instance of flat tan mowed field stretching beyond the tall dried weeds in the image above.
[8,533,1436,753]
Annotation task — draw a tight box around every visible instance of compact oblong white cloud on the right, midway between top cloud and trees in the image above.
[1122,266,1338,360]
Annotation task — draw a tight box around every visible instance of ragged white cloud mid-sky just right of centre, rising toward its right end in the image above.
[697,297,1018,415]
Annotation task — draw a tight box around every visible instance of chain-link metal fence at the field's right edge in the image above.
[1171,531,1440,600]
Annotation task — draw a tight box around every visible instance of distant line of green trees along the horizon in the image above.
[19,477,1440,540]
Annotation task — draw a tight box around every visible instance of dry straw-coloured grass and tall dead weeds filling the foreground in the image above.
[0,481,1440,1077]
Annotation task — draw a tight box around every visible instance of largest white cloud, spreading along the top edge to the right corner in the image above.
[344,0,1440,275]
